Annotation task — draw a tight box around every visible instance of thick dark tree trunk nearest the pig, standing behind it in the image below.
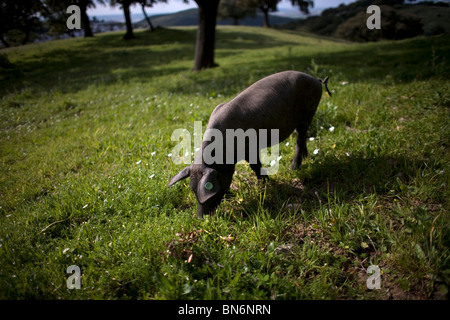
[192,0,220,71]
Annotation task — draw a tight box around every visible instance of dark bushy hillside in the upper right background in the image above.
[282,0,450,41]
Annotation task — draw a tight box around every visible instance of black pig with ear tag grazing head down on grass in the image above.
[169,71,331,218]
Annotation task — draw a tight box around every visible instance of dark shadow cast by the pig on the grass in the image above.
[236,155,428,217]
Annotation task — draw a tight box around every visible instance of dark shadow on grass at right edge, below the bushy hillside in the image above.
[315,37,450,83]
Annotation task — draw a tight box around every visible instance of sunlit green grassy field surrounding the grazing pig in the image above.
[0,27,450,299]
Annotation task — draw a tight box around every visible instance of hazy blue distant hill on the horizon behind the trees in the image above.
[135,9,295,28]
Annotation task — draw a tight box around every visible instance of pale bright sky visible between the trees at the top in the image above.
[88,0,354,17]
